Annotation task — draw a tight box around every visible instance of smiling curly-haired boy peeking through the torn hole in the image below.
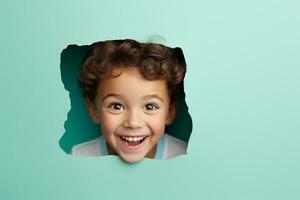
[71,39,187,163]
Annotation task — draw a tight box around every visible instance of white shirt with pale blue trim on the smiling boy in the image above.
[71,133,187,160]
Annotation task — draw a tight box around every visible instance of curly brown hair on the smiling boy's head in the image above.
[78,39,186,106]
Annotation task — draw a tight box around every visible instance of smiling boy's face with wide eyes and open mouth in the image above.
[87,67,175,163]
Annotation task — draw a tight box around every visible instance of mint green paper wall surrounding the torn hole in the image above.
[0,0,300,200]
